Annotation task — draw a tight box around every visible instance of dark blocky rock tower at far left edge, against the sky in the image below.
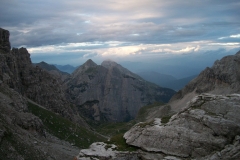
[0,28,11,52]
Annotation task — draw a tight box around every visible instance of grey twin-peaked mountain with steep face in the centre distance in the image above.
[65,60,175,121]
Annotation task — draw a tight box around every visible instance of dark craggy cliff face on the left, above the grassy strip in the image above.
[0,30,87,126]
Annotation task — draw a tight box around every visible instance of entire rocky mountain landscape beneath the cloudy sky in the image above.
[0,28,240,160]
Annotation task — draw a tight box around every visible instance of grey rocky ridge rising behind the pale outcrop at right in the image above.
[171,51,240,101]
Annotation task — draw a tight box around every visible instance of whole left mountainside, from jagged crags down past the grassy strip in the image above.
[0,28,109,160]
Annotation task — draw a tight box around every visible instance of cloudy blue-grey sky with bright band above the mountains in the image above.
[0,0,240,78]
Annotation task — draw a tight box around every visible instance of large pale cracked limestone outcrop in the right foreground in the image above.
[124,94,240,159]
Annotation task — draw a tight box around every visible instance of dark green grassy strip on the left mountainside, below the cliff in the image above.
[28,102,106,148]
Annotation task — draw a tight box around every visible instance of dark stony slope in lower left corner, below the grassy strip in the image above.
[0,81,79,160]
